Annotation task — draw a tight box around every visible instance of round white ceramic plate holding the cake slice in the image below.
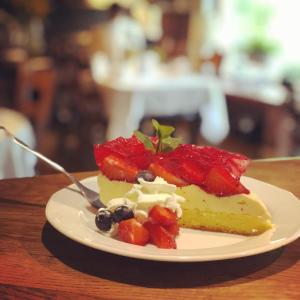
[46,177,300,262]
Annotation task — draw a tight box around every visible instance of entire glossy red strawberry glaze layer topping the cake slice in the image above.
[94,136,250,196]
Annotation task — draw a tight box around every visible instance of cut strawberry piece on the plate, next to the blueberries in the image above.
[118,218,150,246]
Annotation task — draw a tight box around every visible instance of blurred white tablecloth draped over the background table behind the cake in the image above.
[99,74,229,144]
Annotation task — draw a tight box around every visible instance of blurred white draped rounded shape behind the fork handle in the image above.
[0,108,36,179]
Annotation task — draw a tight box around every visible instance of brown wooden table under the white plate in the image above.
[0,159,300,299]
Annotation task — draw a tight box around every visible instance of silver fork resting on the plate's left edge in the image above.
[0,125,106,208]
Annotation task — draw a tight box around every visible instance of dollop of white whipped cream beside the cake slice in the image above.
[107,177,185,221]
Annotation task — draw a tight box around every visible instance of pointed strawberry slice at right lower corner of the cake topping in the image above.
[204,166,249,196]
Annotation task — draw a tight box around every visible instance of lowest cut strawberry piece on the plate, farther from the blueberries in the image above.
[144,221,177,249]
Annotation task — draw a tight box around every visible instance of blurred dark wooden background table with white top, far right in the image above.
[223,80,295,157]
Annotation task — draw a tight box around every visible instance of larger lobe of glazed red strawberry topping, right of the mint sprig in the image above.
[149,145,249,196]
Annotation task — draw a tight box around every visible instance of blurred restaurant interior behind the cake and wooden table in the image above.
[0,0,300,177]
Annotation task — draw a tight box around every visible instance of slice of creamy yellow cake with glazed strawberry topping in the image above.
[94,120,272,235]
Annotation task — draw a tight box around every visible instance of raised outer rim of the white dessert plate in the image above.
[45,176,300,263]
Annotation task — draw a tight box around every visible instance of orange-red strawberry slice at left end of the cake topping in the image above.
[100,155,139,182]
